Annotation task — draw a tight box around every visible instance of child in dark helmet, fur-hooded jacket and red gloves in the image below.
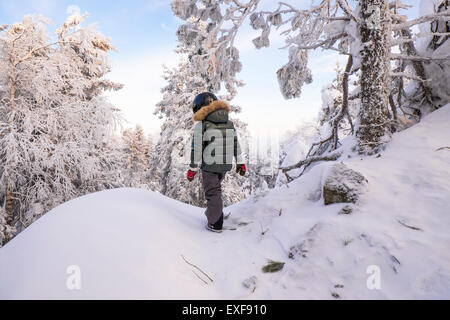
[187,92,247,233]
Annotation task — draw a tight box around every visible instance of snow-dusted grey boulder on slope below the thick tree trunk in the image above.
[323,163,368,205]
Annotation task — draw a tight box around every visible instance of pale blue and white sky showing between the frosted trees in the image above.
[0,0,419,138]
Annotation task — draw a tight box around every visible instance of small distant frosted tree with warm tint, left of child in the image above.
[121,125,153,189]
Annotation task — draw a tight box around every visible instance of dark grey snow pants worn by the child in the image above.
[202,170,226,224]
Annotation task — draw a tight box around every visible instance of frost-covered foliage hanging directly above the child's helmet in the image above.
[172,0,259,101]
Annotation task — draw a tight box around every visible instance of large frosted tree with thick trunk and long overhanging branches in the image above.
[172,0,450,182]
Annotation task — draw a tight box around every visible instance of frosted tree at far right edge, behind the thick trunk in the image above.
[390,0,450,124]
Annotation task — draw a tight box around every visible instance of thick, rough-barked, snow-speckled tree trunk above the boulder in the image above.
[356,0,391,155]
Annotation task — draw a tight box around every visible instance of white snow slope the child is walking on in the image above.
[0,105,450,299]
